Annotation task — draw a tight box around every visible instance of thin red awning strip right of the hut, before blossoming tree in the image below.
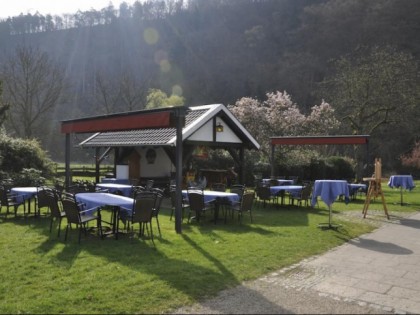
[271,136,369,145]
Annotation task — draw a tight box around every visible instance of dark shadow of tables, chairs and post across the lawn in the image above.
[6,207,286,312]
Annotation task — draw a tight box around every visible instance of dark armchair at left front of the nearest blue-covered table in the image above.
[61,194,103,244]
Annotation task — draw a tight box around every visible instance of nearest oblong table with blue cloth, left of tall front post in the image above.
[75,192,134,239]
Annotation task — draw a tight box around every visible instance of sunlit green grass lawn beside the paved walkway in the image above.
[0,182,420,314]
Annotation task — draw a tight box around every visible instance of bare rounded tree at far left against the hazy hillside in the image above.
[1,46,67,139]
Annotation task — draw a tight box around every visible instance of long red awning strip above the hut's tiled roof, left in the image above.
[61,112,172,133]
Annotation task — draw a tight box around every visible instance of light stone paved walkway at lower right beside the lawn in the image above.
[176,213,420,314]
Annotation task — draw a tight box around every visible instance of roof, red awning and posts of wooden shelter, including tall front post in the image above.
[61,104,259,233]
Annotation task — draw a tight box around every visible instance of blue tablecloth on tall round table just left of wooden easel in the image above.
[311,180,349,207]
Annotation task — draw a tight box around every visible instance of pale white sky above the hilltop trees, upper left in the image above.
[0,0,135,19]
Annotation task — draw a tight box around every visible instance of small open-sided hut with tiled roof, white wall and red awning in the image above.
[61,104,260,232]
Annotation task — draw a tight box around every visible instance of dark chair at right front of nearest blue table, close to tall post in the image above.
[130,193,157,245]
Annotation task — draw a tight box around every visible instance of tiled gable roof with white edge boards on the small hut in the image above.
[79,104,260,149]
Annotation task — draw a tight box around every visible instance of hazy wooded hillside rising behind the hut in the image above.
[0,0,420,173]
